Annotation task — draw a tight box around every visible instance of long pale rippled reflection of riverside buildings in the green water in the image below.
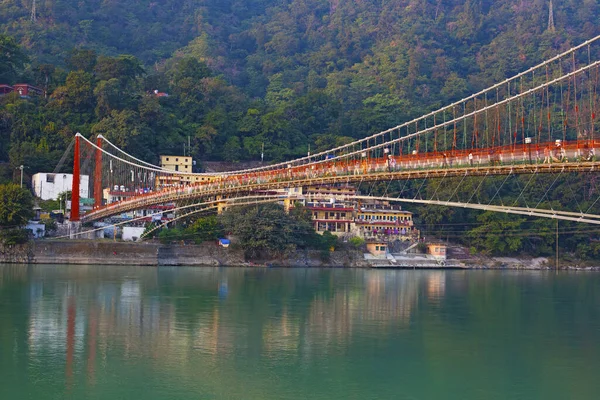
[22,271,454,379]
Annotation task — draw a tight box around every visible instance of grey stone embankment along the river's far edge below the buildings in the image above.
[0,240,600,271]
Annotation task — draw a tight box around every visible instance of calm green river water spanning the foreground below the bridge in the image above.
[0,265,600,400]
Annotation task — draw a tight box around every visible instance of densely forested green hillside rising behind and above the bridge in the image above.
[0,0,600,256]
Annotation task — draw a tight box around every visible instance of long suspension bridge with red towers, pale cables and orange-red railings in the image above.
[59,36,600,236]
